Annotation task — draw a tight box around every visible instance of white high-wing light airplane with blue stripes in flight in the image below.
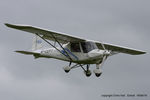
[5,23,146,77]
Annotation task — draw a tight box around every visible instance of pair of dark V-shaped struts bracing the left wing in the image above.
[35,33,72,61]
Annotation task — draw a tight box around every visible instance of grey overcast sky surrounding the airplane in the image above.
[0,0,150,100]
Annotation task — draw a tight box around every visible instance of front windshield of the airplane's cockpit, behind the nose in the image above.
[81,42,97,53]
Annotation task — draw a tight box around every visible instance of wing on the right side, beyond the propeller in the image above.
[95,42,146,55]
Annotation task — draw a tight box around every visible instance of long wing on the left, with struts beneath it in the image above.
[5,23,85,43]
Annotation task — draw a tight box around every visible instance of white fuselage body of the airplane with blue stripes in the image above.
[35,48,104,64]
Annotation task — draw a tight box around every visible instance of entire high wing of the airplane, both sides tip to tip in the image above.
[5,23,146,55]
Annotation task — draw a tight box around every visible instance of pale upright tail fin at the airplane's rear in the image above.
[32,35,42,51]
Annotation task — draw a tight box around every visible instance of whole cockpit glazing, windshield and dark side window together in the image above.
[70,42,97,53]
